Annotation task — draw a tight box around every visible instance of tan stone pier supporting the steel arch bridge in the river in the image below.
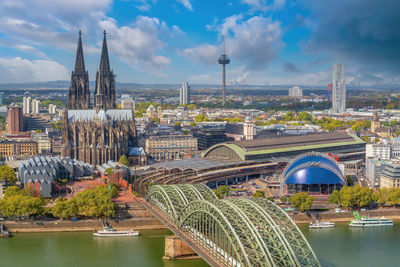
[163,235,200,260]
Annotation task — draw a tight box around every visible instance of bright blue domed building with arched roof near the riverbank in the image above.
[282,152,345,195]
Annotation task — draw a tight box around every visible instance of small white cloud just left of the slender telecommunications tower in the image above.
[180,44,218,65]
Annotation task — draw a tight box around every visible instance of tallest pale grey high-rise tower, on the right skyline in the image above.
[332,63,346,114]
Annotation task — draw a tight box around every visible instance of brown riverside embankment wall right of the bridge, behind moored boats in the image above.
[290,209,400,224]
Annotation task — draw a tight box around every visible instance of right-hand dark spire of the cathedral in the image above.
[94,31,115,110]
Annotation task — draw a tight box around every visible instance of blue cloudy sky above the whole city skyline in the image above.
[0,0,400,85]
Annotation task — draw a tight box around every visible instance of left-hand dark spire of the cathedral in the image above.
[68,31,90,109]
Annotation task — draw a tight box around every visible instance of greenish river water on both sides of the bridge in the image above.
[0,224,400,267]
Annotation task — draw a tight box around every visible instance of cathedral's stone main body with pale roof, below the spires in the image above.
[62,109,136,165]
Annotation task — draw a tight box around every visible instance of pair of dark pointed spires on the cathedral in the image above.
[68,31,115,110]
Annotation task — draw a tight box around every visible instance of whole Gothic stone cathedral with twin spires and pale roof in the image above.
[62,31,137,165]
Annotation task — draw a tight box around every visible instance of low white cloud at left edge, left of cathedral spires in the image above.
[0,57,69,83]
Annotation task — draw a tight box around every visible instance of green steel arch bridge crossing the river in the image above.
[146,184,320,266]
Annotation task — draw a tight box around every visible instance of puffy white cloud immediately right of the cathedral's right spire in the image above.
[100,16,171,69]
